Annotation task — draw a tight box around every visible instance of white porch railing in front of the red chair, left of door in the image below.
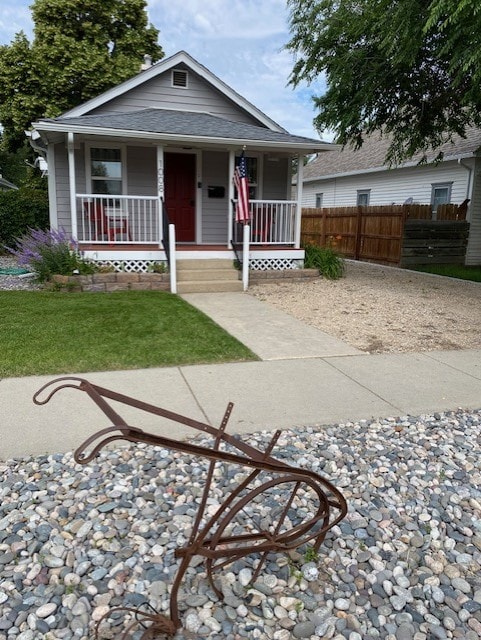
[76,194,161,244]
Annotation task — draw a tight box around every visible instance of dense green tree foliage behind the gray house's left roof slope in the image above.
[0,0,163,149]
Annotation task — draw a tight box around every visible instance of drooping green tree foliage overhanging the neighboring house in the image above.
[287,0,481,163]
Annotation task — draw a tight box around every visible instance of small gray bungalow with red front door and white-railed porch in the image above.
[32,51,331,290]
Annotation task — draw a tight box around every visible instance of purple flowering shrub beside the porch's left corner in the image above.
[8,229,96,282]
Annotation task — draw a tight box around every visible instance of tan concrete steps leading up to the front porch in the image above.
[177,259,243,293]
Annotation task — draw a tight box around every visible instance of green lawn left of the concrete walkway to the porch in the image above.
[0,291,257,378]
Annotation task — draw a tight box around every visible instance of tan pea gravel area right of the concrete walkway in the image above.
[249,261,481,353]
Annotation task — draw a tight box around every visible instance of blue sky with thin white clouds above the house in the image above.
[0,0,330,140]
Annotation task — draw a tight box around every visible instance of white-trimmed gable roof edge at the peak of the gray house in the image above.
[62,51,285,132]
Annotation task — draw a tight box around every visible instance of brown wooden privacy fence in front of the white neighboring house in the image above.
[301,204,466,264]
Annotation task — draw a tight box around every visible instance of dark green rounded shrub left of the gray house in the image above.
[0,187,48,250]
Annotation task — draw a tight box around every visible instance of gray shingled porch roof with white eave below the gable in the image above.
[34,109,337,153]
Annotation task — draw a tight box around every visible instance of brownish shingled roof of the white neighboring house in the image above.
[303,127,481,182]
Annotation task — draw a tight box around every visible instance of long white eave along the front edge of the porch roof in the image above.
[33,122,332,155]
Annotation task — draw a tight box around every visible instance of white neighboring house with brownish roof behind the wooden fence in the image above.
[302,128,481,265]
